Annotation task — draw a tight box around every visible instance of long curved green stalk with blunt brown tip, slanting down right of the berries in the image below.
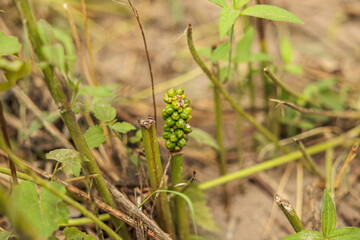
[187,24,289,153]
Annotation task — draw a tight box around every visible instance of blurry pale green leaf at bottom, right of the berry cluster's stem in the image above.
[184,183,220,232]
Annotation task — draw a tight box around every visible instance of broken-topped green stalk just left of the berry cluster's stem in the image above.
[139,118,175,235]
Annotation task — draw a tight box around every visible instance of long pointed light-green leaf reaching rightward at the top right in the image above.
[241,5,304,24]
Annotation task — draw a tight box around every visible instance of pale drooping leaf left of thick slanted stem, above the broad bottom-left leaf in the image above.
[45,148,82,177]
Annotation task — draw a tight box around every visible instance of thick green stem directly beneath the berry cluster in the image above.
[171,152,190,240]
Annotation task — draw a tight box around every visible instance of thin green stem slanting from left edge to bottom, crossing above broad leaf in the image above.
[0,135,122,240]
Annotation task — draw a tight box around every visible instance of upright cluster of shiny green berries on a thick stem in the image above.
[162,88,192,151]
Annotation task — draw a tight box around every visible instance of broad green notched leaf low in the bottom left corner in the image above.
[10,181,68,238]
